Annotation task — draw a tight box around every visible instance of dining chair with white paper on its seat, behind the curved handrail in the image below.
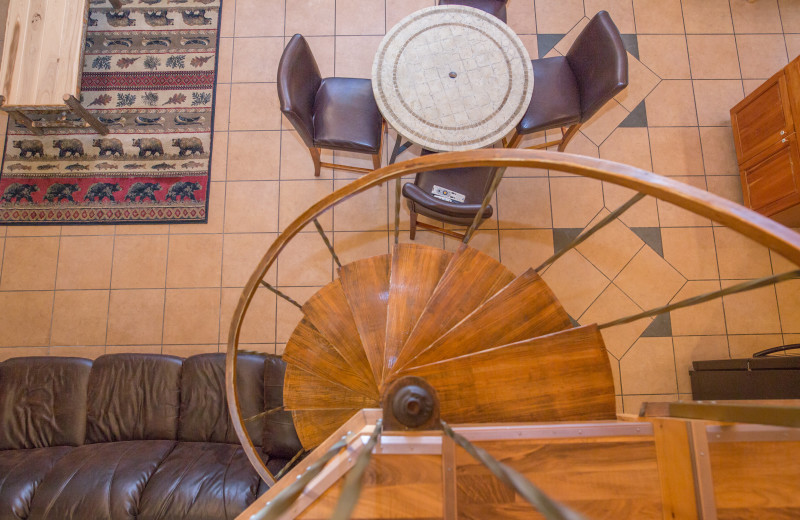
[403,150,494,240]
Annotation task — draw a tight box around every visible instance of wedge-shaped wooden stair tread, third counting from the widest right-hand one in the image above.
[392,246,514,373]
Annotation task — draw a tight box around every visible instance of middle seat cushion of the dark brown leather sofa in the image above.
[31,441,176,520]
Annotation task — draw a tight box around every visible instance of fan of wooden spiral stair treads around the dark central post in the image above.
[283,244,615,449]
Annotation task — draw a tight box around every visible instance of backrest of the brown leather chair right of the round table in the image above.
[567,11,628,122]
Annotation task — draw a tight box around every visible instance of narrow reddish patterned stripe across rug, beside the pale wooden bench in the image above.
[81,71,214,91]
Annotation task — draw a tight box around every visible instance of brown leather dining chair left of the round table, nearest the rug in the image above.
[278,34,383,177]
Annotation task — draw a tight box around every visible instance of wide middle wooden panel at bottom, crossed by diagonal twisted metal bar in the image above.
[456,438,662,520]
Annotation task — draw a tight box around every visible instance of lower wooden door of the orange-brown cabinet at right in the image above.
[741,134,800,216]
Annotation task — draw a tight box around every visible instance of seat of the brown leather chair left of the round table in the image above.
[314,78,383,154]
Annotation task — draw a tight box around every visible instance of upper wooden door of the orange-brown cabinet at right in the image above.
[731,71,794,164]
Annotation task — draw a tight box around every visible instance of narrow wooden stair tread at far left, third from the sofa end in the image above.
[283,318,379,399]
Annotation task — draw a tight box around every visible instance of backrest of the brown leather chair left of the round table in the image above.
[278,34,322,148]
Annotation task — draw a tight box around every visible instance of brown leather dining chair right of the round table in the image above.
[507,11,628,152]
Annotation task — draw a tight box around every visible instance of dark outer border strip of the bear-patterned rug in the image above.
[0,0,225,227]
